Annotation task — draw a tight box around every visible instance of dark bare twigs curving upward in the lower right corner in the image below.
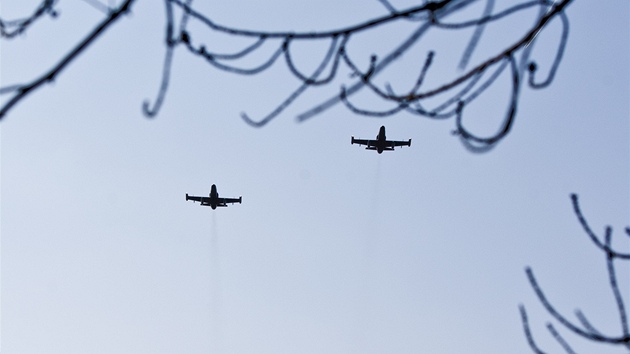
[519,194,630,353]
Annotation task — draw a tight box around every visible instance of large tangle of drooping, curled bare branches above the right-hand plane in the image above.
[162,0,572,152]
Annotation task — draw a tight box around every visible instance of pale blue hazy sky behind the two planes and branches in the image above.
[0,0,630,354]
